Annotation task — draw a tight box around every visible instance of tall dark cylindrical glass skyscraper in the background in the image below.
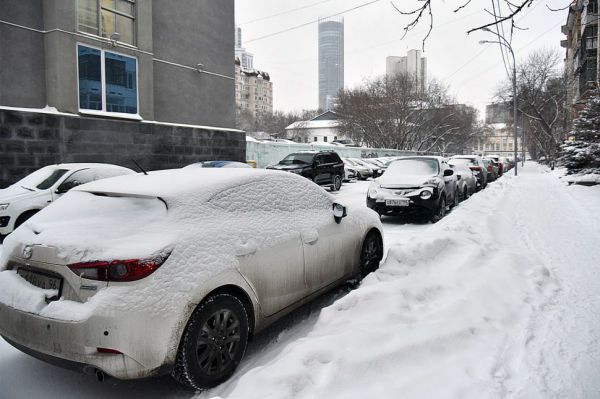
[319,18,344,110]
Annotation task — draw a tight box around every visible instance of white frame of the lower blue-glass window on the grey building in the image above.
[75,42,142,120]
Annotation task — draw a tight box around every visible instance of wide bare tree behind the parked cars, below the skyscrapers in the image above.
[336,74,476,152]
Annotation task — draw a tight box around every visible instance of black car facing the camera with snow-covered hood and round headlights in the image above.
[367,156,458,222]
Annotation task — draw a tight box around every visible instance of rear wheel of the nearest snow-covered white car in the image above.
[171,294,249,389]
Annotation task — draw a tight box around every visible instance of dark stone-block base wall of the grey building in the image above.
[0,110,246,188]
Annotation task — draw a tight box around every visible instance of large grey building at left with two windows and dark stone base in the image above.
[0,0,245,188]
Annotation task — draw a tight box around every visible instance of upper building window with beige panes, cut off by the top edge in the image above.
[78,0,135,45]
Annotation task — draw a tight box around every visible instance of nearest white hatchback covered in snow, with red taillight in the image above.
[0,168,383,389]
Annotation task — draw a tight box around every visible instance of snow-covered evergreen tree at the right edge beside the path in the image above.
[559,95,600,180]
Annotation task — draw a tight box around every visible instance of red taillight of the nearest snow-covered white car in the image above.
[68,254,170,282]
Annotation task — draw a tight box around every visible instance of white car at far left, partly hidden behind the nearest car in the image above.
[0,163,135,237]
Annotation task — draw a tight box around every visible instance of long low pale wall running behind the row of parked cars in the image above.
[246,141,417,168]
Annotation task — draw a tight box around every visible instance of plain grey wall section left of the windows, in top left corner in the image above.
[0,0,46,108]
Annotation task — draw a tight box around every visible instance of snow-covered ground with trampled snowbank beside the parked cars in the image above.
[0,163,600,399]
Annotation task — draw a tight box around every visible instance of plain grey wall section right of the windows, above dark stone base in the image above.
[152,0,235,128]
